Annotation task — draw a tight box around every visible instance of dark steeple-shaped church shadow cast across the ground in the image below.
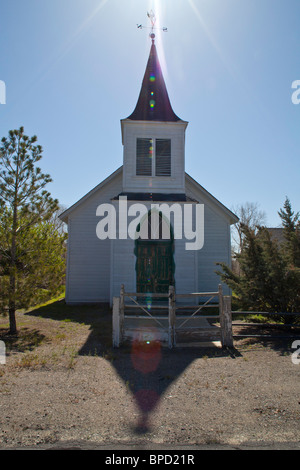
[27,300,298,434]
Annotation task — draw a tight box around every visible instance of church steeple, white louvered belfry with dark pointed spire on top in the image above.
[121,28,188,196]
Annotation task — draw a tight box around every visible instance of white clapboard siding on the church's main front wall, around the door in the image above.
[62,168,237,303]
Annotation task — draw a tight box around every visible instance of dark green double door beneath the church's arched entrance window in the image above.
[136,240,174,294]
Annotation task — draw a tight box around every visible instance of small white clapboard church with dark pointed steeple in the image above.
[60,35,238,304]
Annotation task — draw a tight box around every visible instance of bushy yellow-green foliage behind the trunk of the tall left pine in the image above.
[0,215,67,310]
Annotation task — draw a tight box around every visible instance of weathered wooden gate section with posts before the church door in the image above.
[113,285,233,348]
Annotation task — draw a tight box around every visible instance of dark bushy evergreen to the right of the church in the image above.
[218,200,300,322]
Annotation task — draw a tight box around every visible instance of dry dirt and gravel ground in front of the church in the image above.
[0,302,300,449]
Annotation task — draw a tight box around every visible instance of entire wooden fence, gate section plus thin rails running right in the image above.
[113,285,300,348]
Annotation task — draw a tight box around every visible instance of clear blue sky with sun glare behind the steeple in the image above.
[0,0,300,226]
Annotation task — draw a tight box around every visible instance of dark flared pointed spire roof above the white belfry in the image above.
[127,35,180,122]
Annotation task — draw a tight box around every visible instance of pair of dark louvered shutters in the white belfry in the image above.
[136,138,171,176]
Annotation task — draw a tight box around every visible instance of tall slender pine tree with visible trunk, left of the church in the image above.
[0,127,62,334]
